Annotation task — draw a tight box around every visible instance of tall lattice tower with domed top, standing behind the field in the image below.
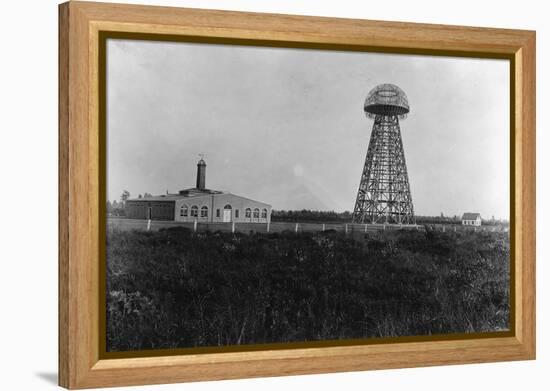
[353,84,416,224]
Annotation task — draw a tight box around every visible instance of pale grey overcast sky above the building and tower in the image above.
[107,39,509,219]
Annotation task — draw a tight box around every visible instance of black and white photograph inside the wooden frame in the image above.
[105,38,512,352]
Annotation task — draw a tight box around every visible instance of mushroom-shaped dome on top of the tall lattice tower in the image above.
[364,84,409,119]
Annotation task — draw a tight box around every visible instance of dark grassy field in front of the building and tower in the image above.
[107,228,510,351]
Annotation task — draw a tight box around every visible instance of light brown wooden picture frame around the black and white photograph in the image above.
[59,1,535,389]
